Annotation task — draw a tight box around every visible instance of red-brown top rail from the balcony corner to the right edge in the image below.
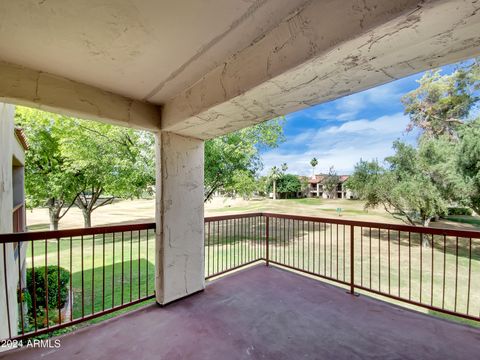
[262,212,480,238]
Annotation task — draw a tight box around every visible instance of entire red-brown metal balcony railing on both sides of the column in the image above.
[0,213,480,339]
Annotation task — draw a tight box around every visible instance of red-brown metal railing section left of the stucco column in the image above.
[0,223,155,340]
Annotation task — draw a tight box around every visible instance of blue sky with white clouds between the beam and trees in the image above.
[262,61,470,175]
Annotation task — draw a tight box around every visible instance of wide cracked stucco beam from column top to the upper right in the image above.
[162,0,480,139]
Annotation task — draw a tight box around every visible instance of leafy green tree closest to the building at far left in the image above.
[15,106,77,230]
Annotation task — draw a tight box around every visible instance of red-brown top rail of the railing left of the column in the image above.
[0,223,155,244]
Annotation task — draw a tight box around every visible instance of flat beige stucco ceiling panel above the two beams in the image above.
[0,0,305,104]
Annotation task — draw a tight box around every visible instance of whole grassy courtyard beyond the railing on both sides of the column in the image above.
[21,199,480,334]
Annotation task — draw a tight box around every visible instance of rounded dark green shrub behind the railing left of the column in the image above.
[27,265,70,312]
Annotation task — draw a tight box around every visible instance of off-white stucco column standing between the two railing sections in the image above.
[155,132,205,305]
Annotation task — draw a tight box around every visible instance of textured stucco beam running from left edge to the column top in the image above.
[0,62,160,131]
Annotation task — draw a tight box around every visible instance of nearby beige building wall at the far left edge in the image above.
[0,103,28,339]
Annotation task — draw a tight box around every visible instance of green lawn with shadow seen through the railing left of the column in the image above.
[23,230,155,334]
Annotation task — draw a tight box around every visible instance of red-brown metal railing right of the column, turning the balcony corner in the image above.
[205,213,480,321]
